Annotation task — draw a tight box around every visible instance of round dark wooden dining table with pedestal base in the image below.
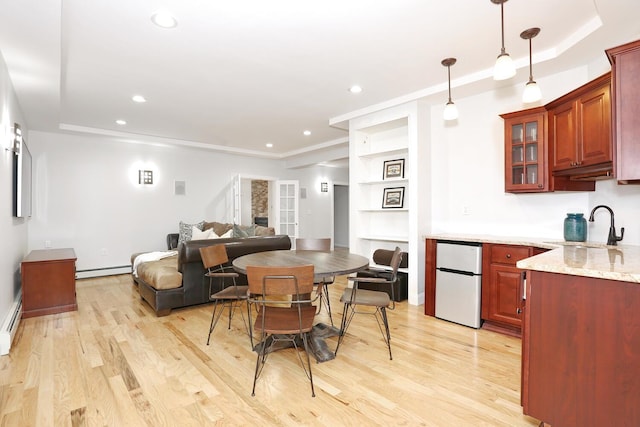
[232,250,369,362]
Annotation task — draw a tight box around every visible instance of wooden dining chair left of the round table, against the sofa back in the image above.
[200,245,253,348]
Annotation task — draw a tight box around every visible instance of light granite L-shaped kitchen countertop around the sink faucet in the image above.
[425,234,640,283]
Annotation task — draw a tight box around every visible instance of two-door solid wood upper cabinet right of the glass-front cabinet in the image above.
[546,73,613,179]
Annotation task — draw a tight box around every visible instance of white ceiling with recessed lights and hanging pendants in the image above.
[0,0,640,158]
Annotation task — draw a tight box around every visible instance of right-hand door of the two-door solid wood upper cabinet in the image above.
[577,84,612,166]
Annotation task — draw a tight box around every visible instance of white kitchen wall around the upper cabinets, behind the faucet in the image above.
[429,63,640,244]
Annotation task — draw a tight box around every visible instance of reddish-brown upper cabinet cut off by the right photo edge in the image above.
[607,40,640,184]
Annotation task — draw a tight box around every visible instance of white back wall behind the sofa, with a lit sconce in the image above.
[29,132,344,276]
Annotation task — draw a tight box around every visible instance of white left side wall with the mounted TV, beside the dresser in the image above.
[0,55,31,332]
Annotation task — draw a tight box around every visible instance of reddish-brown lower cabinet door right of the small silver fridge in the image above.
[489,265,522,327]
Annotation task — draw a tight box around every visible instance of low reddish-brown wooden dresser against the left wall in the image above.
[21,248,78,318]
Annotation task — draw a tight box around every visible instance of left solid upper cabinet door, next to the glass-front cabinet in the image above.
[549,101,578,171]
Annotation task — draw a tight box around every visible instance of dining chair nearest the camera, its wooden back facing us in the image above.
[247,265,316,397]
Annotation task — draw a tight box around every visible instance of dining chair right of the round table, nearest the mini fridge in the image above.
[335,247,402,360]
